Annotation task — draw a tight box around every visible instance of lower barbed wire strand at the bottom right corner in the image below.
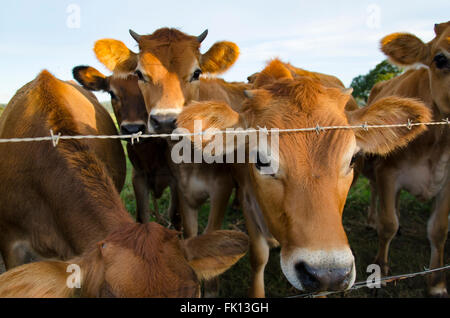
[287,264,450,298]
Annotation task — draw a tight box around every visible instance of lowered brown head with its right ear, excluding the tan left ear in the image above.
[81,223,248,297]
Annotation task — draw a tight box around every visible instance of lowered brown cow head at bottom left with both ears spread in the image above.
[0,223,248,298]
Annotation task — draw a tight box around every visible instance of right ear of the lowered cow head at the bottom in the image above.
[182,230,249,280]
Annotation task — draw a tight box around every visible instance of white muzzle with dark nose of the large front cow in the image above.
[281,248,356,292]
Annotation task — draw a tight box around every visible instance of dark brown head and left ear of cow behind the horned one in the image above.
[72,66,148,135]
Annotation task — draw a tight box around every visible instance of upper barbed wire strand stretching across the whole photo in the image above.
[0,118,450,147]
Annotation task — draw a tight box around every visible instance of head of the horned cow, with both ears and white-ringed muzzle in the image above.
[94,28,239,133]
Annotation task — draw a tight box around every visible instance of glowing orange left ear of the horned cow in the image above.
[94,39,138,76]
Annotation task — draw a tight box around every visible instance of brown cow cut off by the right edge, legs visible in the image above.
[368,22,450,296]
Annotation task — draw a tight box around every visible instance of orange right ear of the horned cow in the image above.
[200,41,239,74]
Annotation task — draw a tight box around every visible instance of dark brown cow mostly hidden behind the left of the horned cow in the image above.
[72,66,178,228]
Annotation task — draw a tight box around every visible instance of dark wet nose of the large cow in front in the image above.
[295,262,353,292]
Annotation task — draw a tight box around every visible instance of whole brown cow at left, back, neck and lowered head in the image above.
[0,71,247,297]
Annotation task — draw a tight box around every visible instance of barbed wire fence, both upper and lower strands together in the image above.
[0,118,450,298]
